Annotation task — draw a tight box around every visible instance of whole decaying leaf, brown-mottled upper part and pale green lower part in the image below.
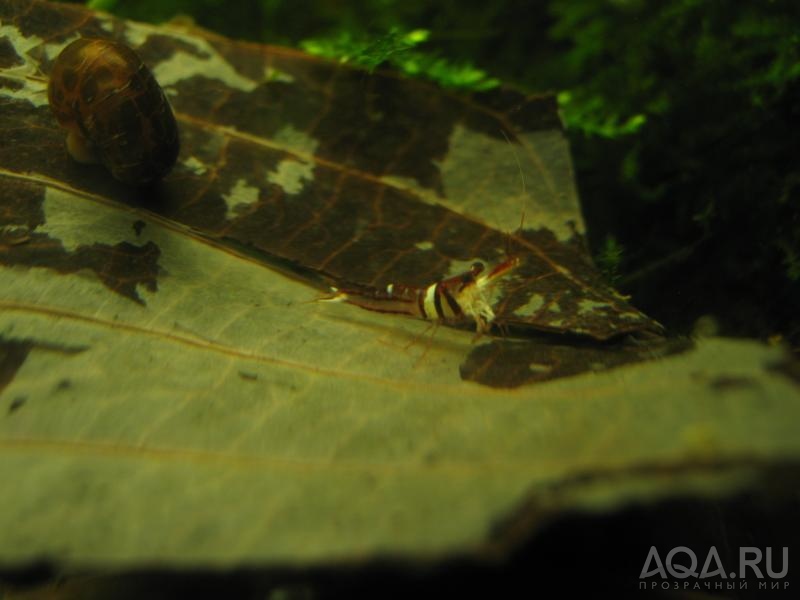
[0,0,800,569]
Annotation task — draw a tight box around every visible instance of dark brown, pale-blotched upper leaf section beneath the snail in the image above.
[0,2,659,386]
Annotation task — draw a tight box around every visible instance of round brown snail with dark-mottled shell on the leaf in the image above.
[47,38,180,185]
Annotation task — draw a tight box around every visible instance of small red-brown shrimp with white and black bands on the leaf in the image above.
[324,257,520,335]
